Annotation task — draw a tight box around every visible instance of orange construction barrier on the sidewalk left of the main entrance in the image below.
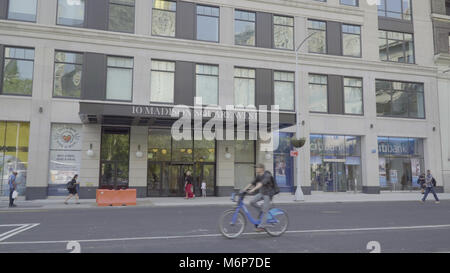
[96,189,136,207]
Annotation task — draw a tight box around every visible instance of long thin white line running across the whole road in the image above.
[0,224,450,246]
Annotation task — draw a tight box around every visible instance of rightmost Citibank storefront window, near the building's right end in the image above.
[378,137,425,191]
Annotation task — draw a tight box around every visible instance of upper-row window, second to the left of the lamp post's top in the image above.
[234,10,256,46]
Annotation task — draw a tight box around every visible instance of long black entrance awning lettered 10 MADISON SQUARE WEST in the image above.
[79,102,296,130]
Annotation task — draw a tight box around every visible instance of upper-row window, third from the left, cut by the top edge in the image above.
[108,0,135,33]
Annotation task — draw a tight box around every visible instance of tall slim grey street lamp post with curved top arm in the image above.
[294,31,318,201]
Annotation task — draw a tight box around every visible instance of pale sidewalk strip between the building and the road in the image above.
[0,192,450,212]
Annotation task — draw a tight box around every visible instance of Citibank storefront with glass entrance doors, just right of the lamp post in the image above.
[310,135,362,192]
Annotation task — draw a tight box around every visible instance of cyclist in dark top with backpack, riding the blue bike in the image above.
[242,164,277,232]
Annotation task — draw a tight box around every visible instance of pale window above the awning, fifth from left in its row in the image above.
[196,64,219,105]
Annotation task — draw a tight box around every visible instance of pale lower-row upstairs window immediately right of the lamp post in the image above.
[309,74,328,113]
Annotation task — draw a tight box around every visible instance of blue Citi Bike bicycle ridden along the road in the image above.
[219,192,289,239]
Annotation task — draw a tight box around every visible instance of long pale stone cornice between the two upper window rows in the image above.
[0,20,437,77]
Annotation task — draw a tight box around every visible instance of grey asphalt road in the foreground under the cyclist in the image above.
[0,201,450,253]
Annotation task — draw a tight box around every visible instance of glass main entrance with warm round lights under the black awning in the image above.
[147,129,216,197]
